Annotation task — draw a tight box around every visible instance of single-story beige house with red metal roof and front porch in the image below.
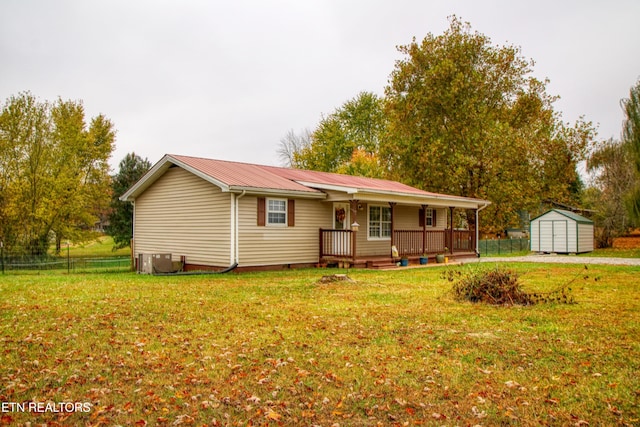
[120,155,489,270]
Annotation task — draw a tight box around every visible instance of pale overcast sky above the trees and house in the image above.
[0,0,640,170]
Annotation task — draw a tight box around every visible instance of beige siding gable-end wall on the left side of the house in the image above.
[134,167,231,266]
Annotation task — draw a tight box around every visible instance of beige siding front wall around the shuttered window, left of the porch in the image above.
[238,196,332,266]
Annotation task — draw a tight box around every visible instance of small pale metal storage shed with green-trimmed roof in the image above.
[529,209,593,253]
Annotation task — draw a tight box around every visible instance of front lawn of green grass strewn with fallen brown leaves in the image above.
[0,263,640,426]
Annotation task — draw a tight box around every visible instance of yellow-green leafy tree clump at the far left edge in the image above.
[0,92,115,254]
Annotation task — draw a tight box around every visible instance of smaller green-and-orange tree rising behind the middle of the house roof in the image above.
[292,92,386,177]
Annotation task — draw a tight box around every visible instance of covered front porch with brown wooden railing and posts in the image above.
[319,200,479,267]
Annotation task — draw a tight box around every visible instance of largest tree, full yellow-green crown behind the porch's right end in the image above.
[380,16,594,230]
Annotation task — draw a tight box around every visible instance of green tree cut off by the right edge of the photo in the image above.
[621,80,640,224]
